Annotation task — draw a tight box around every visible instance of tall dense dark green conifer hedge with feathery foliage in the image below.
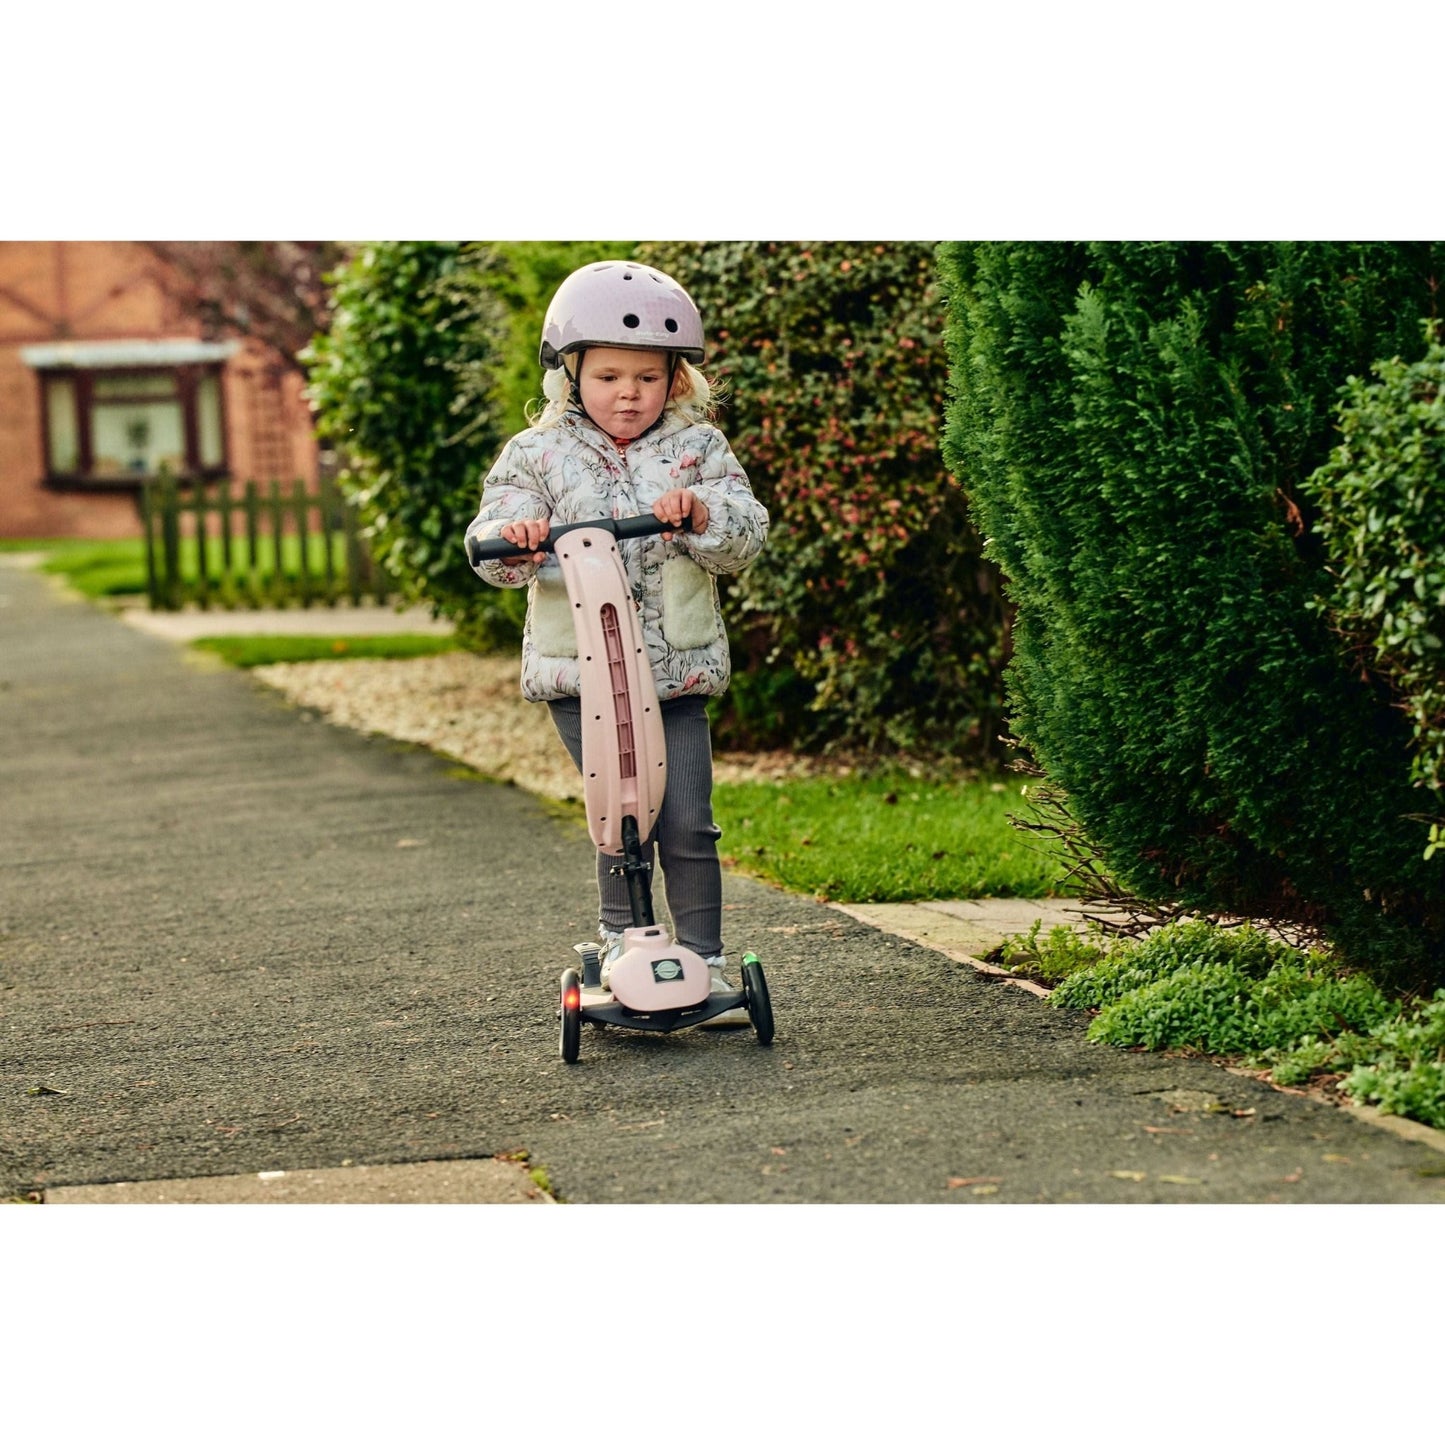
[939,243,1445,981]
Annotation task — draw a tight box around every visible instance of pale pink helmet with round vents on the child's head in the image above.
[540,262,702,371]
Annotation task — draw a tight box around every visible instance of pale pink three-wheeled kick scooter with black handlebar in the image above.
[467,516,773,1064]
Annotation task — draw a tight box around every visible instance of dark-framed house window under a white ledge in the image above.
[22,341,234,487]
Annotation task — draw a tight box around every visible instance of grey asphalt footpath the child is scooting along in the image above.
[0,566,1445,1205]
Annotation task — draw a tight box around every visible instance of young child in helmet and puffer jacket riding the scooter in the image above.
[467,260,767,1025]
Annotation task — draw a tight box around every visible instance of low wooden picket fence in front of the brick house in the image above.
[140,474,392,611]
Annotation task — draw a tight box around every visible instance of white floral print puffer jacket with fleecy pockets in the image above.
[467,407,767,702]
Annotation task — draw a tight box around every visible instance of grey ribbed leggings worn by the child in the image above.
[548,698,723,958]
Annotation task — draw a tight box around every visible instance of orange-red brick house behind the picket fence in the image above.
[0,241,318,538]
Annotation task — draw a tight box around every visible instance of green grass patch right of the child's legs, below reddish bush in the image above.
[712,773,1064,903]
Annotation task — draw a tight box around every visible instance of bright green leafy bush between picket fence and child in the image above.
[302,241,523,647]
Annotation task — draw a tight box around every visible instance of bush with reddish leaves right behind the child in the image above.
[637,241,1006,759]
